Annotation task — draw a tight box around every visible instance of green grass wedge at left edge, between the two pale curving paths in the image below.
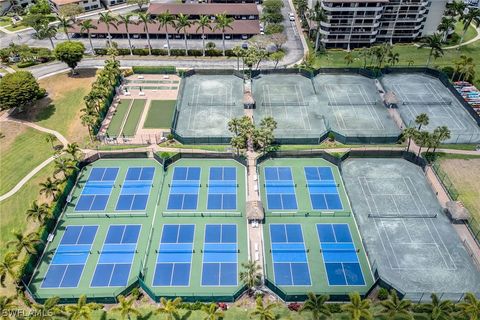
[0,122,53,194]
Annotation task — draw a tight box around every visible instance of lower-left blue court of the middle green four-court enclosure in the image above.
[153,224,195,286]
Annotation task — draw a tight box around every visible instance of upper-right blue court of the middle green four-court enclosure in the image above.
[207,167,238,210]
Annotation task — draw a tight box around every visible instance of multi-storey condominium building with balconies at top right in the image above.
[319,0,448,49]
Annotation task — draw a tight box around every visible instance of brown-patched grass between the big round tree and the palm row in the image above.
[17,70,96,146]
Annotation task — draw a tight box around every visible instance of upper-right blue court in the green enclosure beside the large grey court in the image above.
[304,167,343,210]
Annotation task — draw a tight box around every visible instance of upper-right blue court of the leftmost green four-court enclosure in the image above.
[116,167,155,211]
